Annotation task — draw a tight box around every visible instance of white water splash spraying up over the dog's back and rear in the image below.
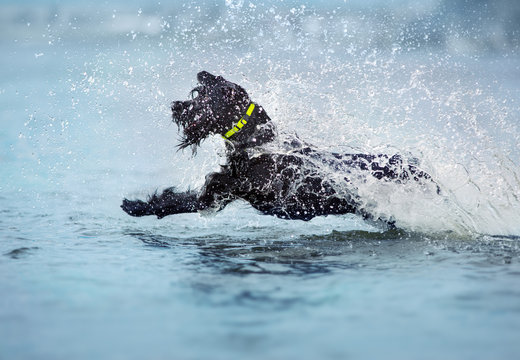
[255,55,520,235]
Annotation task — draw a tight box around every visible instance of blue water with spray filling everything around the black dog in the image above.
[0,0,520,359]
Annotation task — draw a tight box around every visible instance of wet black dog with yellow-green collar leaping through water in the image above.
[121,71,431,222]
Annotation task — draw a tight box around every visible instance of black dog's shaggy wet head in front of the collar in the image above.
[171,71,250,149]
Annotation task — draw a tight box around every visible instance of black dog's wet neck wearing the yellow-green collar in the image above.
[222,103,276,150]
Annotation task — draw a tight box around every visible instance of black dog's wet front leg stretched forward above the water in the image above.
[121,188,201,219]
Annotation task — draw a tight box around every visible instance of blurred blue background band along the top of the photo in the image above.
[2,0,520,52]
